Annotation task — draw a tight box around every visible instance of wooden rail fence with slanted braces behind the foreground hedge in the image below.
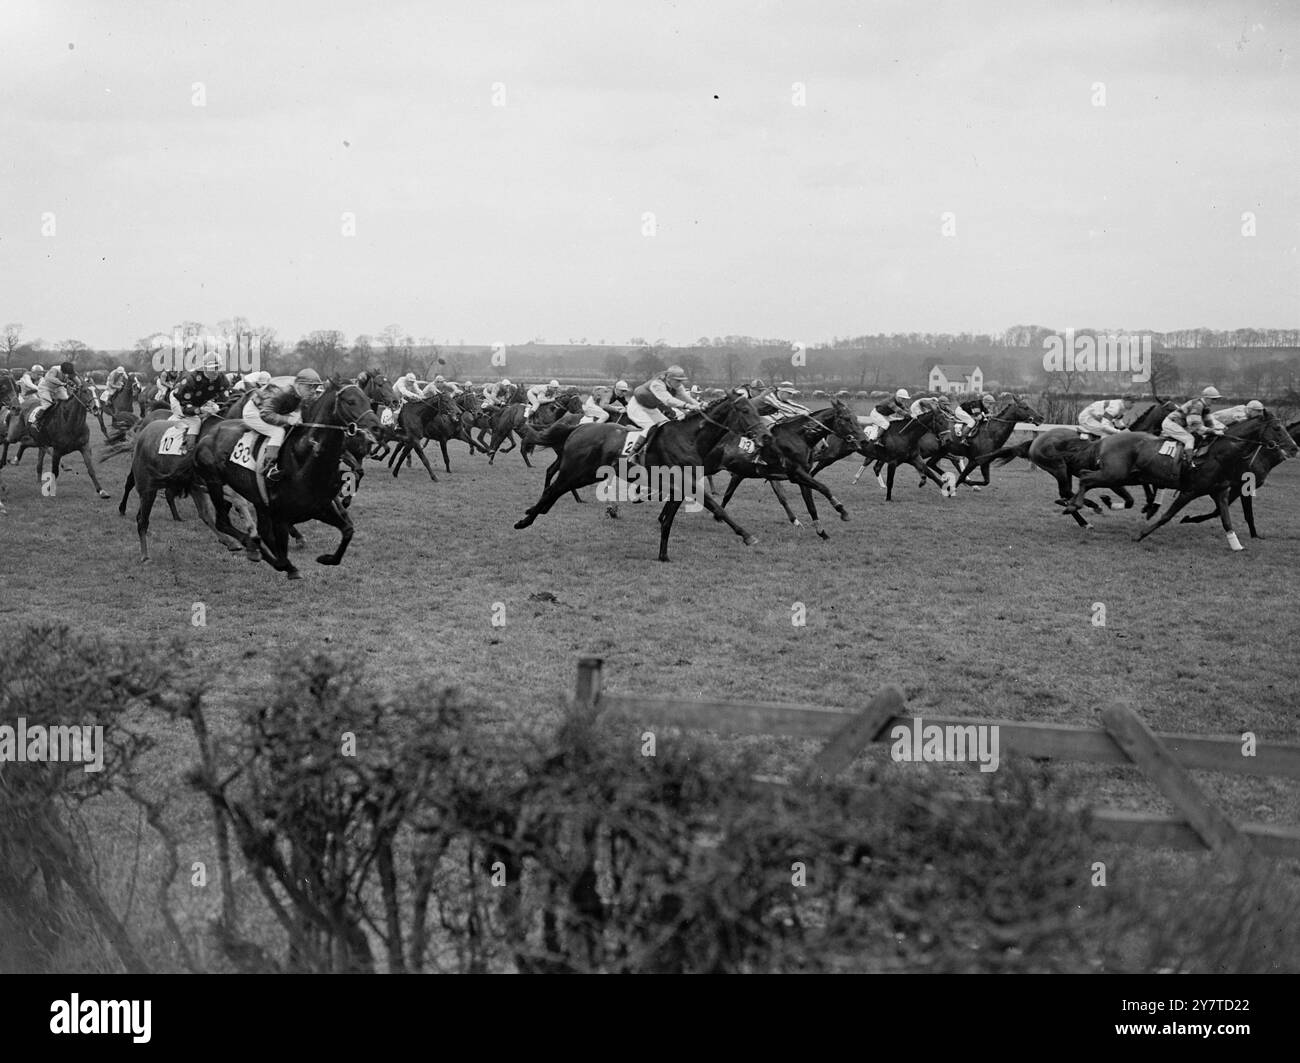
[575,658,1300,865]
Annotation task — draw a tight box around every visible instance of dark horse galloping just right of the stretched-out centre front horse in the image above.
[722,399,866,539]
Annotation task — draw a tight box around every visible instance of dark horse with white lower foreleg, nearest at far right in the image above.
[1058,413,1300,550]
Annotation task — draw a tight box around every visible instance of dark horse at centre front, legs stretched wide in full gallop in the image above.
[515,392,772,561]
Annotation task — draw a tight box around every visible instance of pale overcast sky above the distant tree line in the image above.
[0,0,1300,348]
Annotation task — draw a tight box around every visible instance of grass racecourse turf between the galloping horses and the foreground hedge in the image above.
[0,421,1300,966]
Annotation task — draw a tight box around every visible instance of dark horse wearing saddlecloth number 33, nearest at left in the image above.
[152,377,380,580]
